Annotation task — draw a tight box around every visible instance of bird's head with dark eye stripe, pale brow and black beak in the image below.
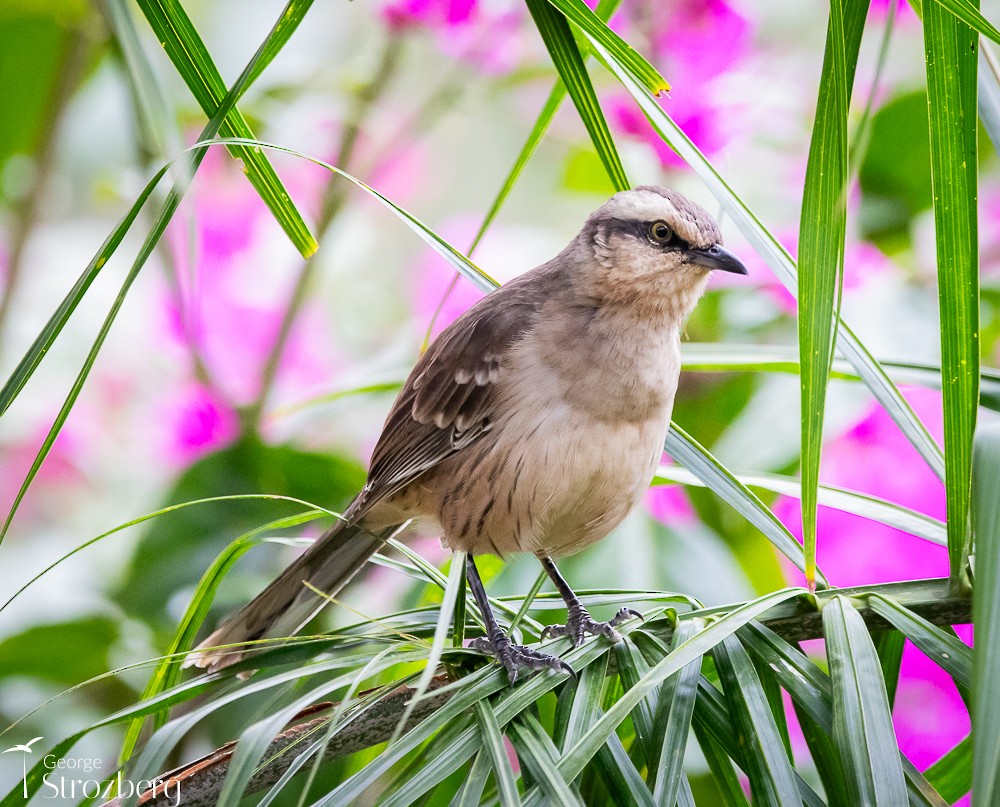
[576,185,747,320]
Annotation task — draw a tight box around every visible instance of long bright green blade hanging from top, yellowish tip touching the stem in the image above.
[798,0,868,590]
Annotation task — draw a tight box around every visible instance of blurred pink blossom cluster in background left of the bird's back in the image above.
[160,150,333,462]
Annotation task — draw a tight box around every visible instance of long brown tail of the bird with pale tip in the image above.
[184,521,400,672]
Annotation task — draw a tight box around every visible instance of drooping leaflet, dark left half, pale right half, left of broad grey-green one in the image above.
[712,636,802,805]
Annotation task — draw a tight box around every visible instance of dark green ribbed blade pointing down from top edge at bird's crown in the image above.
[526,0,631,191]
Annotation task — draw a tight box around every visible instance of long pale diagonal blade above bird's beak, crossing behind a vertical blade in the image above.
[594,34,944,478]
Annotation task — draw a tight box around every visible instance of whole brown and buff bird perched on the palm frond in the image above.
[186,185,747,685]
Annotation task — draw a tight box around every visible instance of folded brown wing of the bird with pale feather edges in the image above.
[352,278,544,517]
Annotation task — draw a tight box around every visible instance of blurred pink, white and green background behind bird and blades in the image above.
[0,0,1000,800]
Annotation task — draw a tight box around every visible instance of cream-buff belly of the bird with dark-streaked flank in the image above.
[430,405,669,557]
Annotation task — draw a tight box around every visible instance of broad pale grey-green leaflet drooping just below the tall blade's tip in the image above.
[823,596,908,807]
